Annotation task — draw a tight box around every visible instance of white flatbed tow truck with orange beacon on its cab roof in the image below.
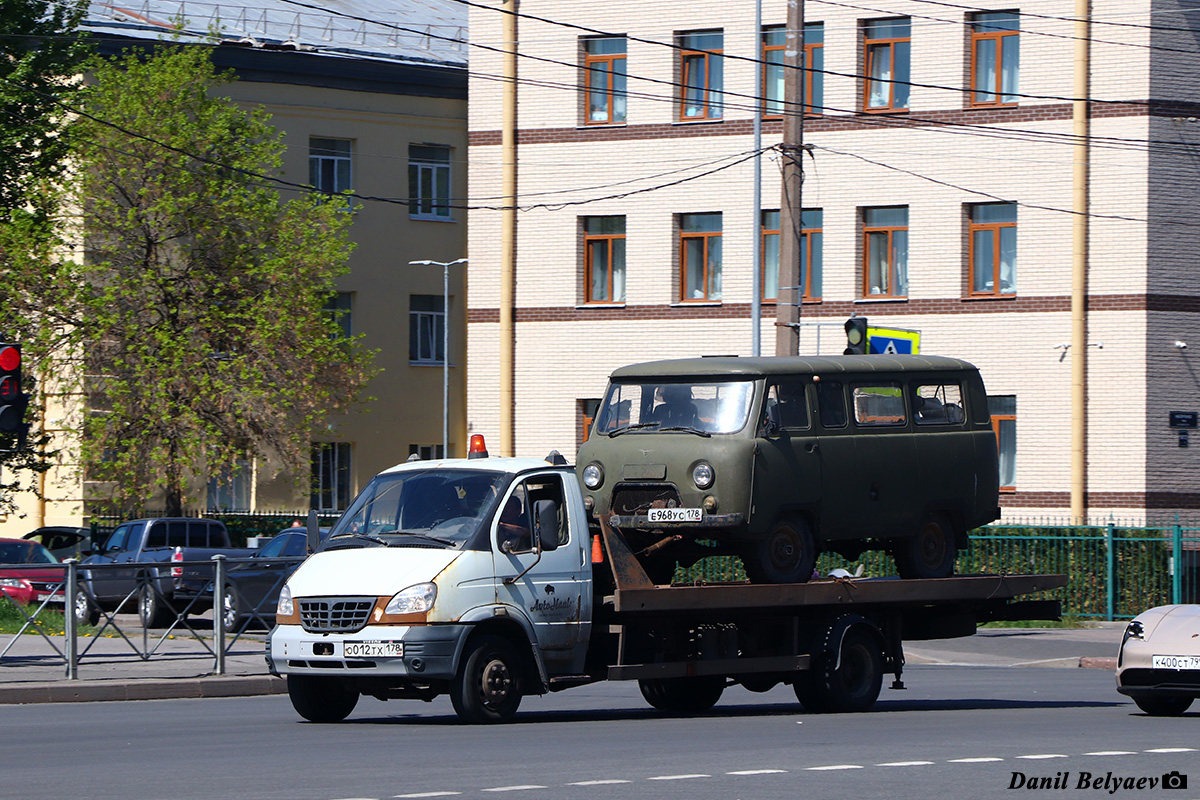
[266,437,1066,722]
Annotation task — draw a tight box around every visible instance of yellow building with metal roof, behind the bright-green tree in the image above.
[0,0,467,536]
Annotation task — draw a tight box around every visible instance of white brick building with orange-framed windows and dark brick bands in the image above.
[467,0,1200,522]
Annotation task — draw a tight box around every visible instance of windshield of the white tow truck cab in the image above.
[324,469,506,549]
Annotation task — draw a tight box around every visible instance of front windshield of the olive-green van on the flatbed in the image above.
[595,380,754,437]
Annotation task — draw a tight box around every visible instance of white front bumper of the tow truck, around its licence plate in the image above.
[266,625,470,681]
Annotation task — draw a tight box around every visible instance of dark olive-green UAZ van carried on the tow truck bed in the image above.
[576,355,1000,583]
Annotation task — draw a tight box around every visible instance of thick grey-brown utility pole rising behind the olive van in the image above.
[775,0,810,355]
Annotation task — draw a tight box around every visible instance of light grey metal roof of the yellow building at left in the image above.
[83,0,467,67]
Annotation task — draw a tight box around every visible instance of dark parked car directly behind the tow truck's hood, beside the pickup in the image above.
[221,528,330,631]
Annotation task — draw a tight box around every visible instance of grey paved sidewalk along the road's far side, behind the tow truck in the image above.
[0,622,1124,704]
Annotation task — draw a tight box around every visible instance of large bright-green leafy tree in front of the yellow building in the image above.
[58,44,371,513]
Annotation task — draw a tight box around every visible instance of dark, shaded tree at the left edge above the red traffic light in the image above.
[0,0,88,513]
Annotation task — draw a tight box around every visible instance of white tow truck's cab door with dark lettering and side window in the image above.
[492,473,589,674]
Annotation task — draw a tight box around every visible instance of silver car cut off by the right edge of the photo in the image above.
[1117,604,1200,716]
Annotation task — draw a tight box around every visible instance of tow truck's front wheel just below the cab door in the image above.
[450,634,521,722]
